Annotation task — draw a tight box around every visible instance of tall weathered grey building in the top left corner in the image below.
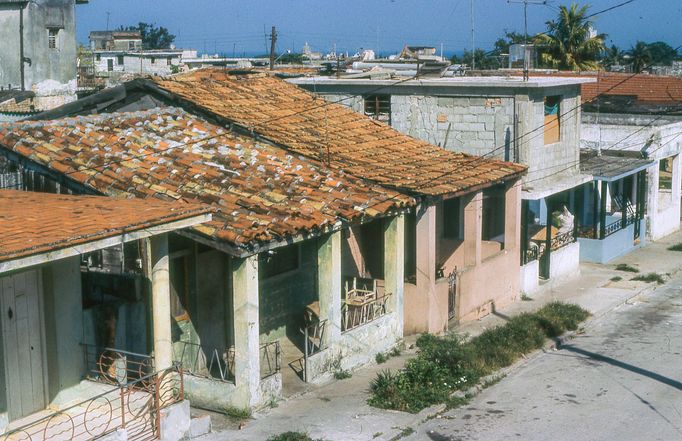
[0,0,87,120]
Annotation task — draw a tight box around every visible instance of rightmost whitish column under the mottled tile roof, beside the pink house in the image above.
[384,214,405,337]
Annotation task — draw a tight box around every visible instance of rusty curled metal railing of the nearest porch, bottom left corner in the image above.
[0,365,185,441]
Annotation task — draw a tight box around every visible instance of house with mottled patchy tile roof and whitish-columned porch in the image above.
[0,107,414,410]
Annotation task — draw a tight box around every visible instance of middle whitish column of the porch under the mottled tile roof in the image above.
[317,231,342,347]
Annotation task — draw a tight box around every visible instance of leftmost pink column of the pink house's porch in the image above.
[417,202,436,333]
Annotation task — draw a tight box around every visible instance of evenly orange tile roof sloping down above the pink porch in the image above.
[154,69,526,195]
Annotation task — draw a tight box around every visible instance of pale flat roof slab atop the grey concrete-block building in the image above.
[287,76,597,89]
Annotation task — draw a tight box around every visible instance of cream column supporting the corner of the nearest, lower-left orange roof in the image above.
[149,234,173,371]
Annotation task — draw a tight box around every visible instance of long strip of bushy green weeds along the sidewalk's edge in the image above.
[368,302,589,413]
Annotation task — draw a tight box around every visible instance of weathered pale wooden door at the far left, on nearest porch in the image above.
[0,270,46,421]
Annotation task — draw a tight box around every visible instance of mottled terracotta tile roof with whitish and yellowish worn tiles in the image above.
[0,108,415,252]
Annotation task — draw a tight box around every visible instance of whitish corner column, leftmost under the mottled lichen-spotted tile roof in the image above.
[232,254,260,408]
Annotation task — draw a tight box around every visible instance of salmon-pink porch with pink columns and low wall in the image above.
[405,182,520,334]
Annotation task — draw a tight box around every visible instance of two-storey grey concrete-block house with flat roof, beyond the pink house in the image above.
[289,72,593,292]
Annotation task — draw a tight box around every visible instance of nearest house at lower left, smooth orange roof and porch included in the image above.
[0,190,211,439]
